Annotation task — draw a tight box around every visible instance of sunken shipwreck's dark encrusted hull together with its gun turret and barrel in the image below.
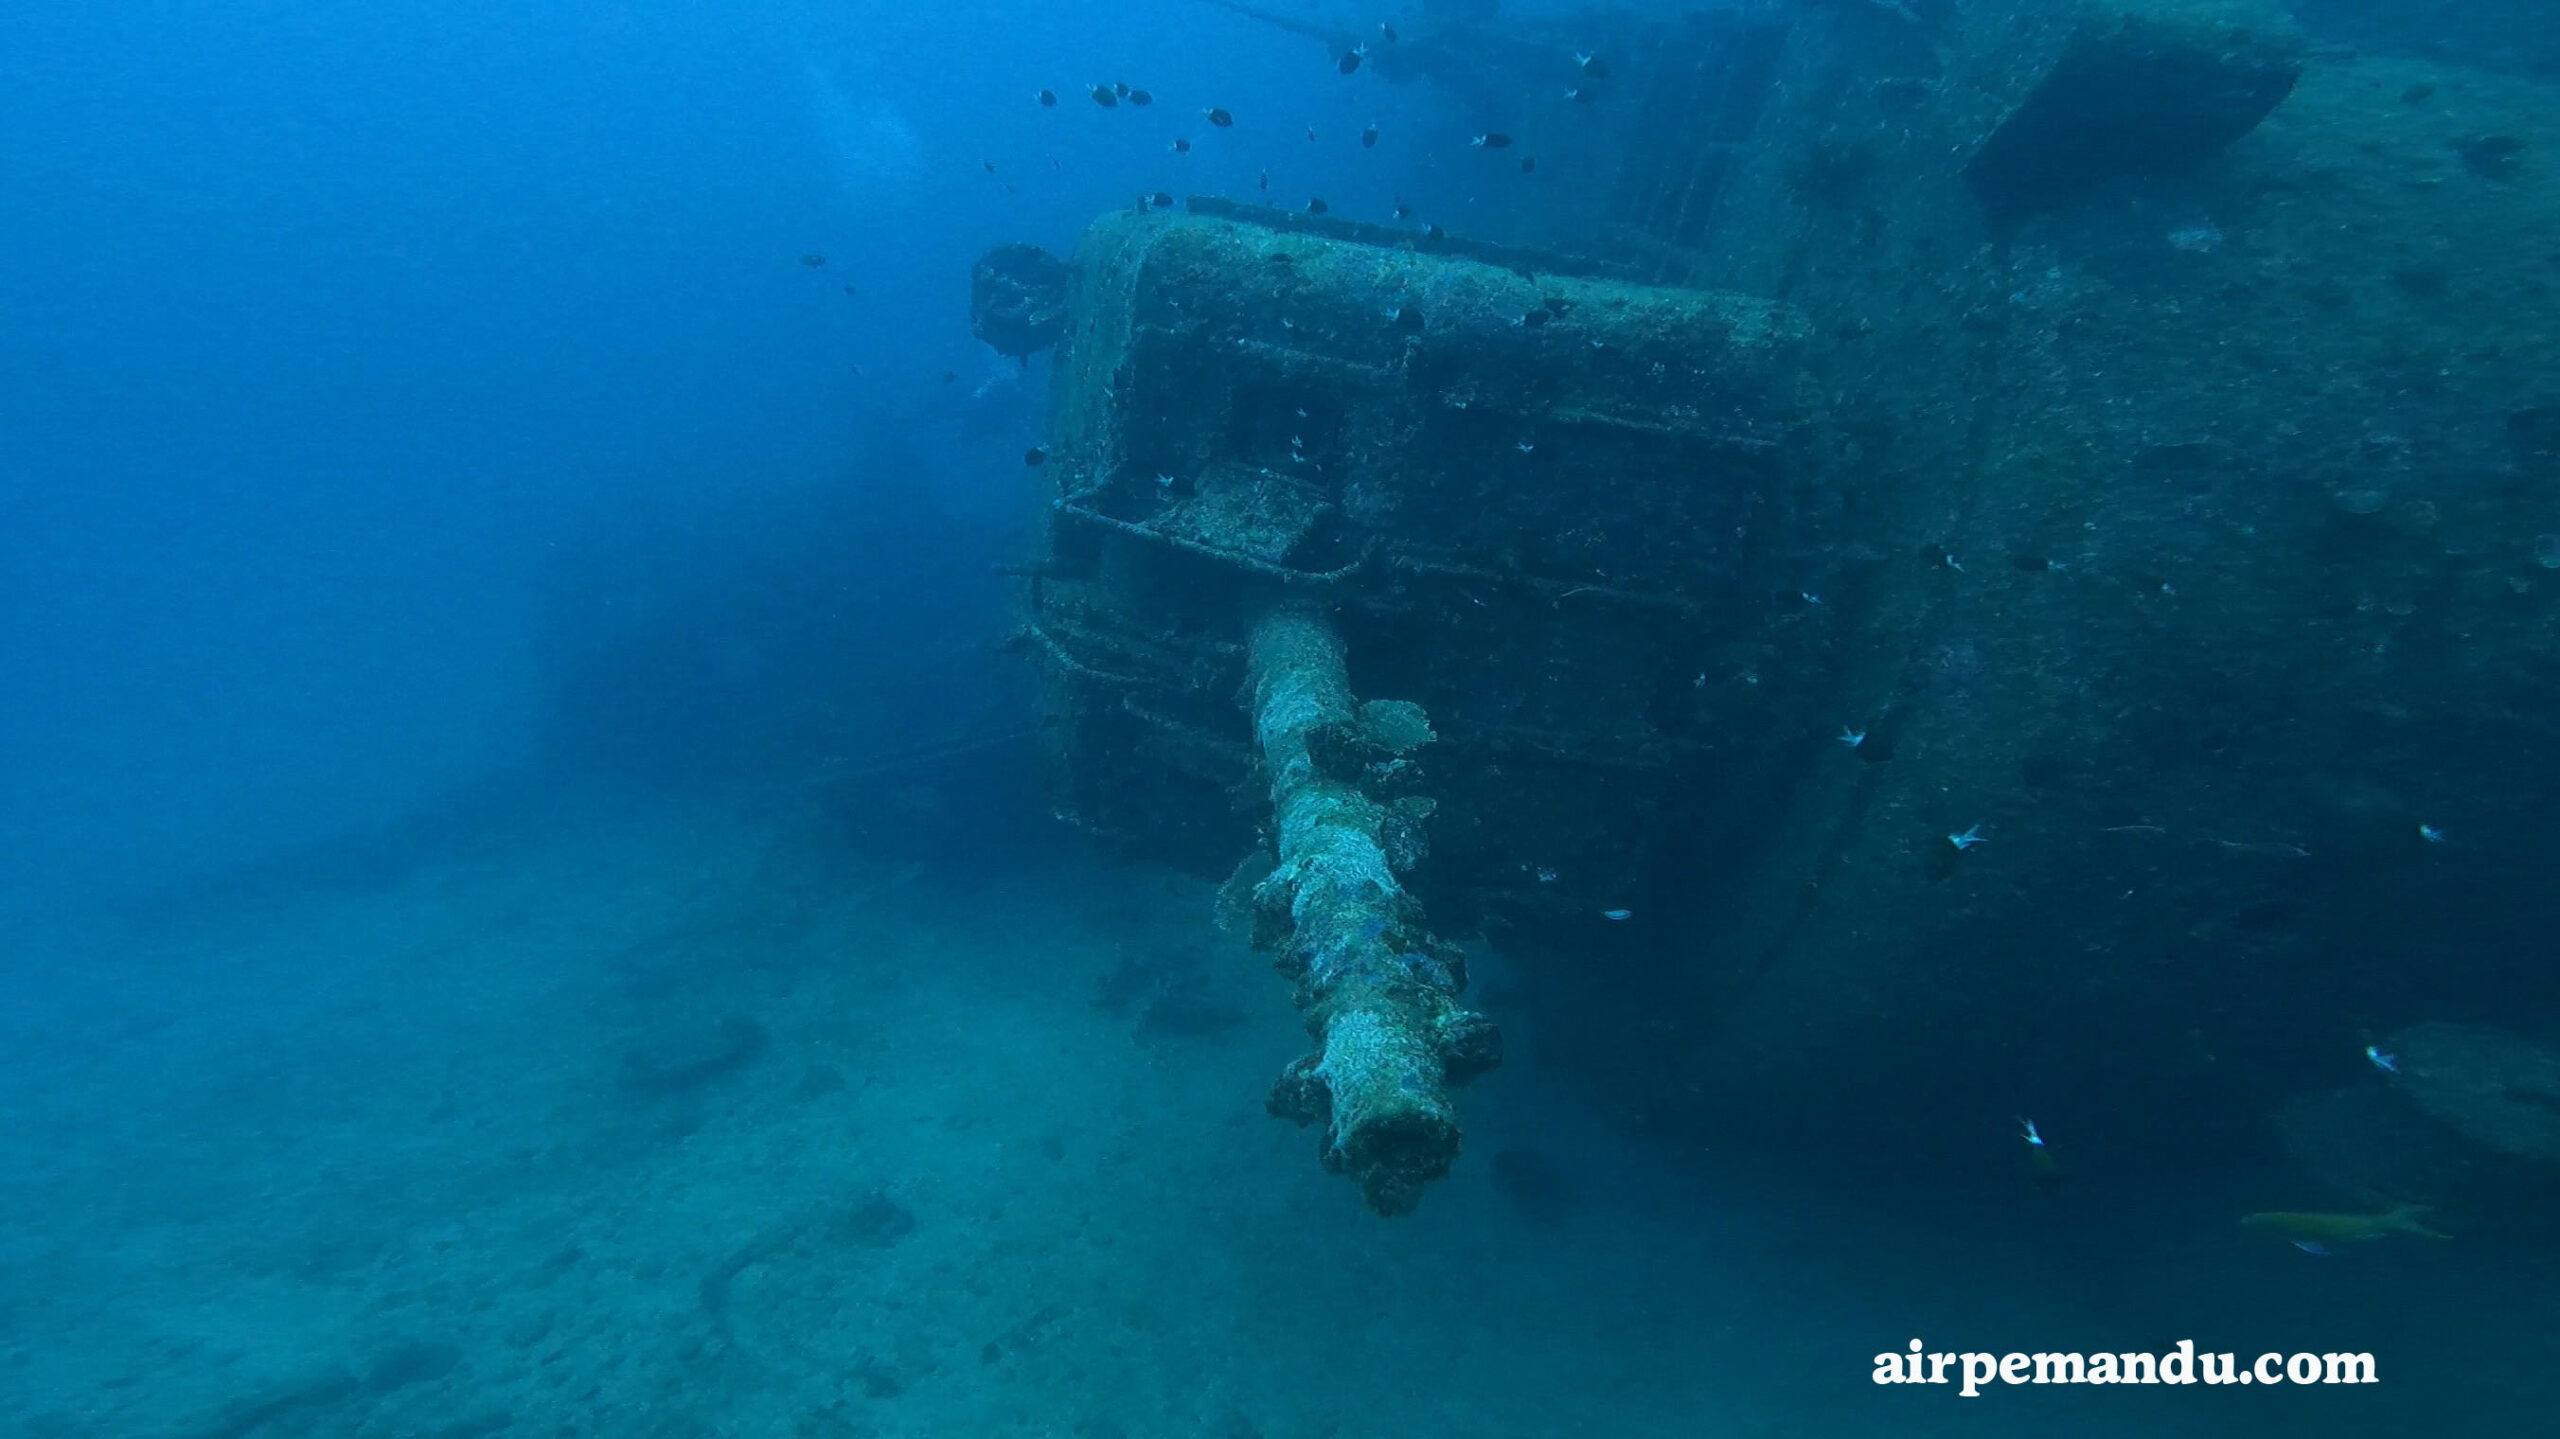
[962,0,2560,1211]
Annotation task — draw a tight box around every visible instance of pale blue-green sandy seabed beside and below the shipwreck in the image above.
[0,783,2478,1439]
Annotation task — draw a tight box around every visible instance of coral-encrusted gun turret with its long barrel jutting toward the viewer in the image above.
[993,200,1810,1214]
